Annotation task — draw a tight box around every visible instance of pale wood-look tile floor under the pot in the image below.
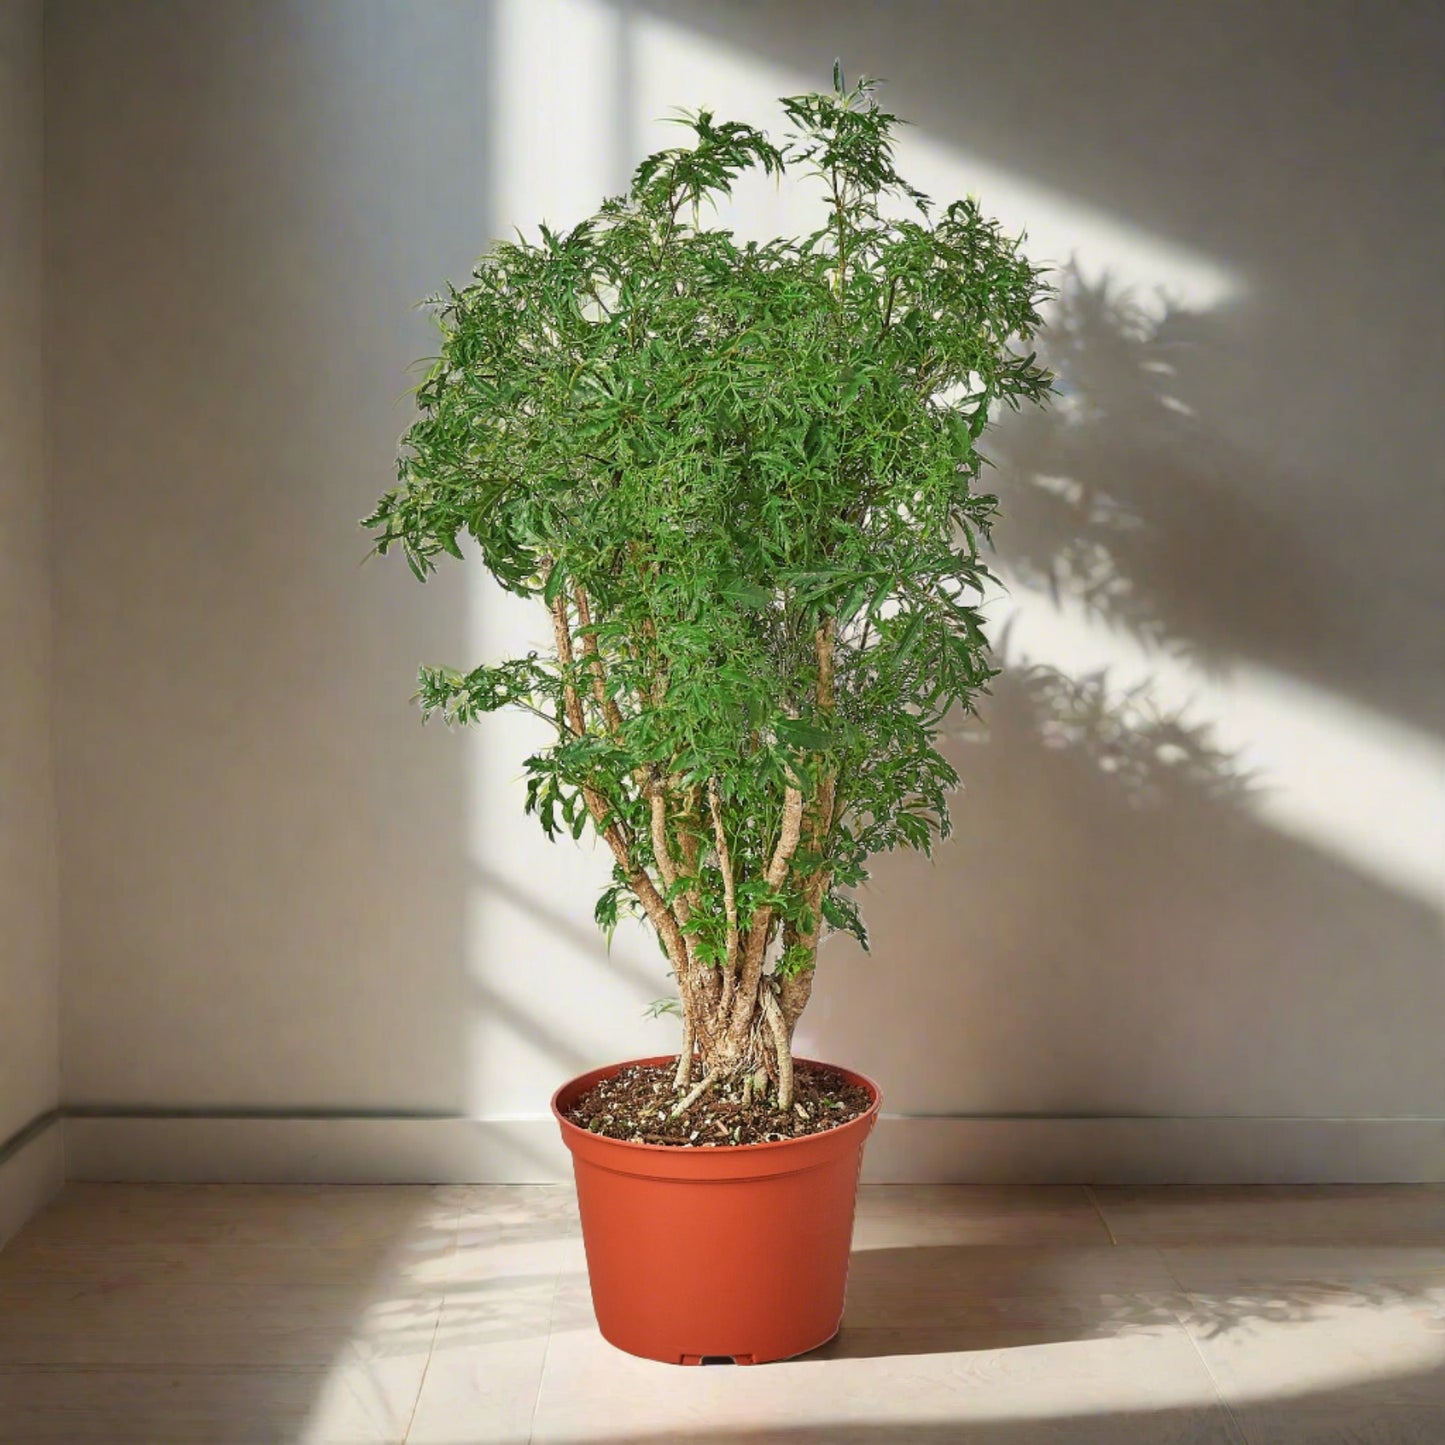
[0,1185,1445,1445]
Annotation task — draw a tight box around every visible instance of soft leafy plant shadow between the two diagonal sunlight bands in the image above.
[997,264,1344,681]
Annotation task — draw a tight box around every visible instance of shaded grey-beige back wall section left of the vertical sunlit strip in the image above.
[46,3,484,1110]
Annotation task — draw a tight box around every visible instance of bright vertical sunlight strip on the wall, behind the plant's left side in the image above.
[457,0,661,1118]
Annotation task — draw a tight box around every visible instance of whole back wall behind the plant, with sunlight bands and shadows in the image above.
[48,0,1445,1173]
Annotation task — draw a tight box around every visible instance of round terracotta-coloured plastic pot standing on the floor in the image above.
[552,1056,881,1364]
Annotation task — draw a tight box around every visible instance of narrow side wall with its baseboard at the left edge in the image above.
[0,0,59,1241]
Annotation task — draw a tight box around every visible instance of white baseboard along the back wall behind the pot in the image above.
[62,1116,1445,1190]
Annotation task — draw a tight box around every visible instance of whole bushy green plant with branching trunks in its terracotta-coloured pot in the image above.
[363,71,1049,1361]
